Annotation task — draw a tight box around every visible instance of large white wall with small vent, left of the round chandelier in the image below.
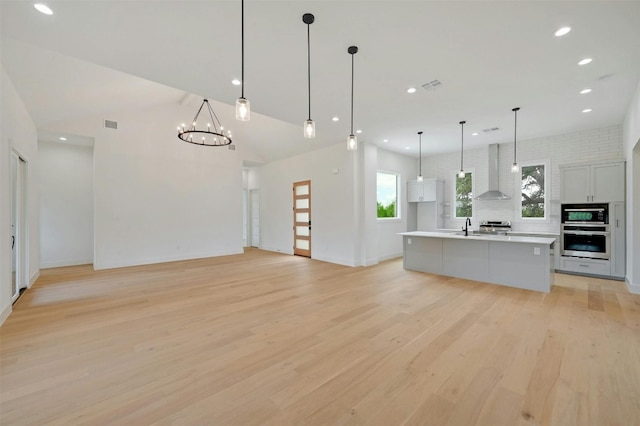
[42,99,243,269]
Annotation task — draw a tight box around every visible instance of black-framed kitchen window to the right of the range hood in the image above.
[519,162,547,219]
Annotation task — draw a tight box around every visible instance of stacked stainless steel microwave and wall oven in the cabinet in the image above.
[560,204,611,259]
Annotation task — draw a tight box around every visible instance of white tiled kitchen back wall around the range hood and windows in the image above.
[422,126,623,232]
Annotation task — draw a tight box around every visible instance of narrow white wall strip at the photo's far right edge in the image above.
[623,83,640,293]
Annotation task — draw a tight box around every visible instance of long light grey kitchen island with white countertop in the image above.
[400,231,555,293]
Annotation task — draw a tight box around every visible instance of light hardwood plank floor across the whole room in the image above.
[0,249,640,426]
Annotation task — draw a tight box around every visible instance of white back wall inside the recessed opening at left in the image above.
[38,142,93,268]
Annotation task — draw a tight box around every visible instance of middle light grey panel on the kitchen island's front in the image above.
[442,238,489,281]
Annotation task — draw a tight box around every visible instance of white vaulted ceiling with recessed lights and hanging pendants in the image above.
[0,0,640,161]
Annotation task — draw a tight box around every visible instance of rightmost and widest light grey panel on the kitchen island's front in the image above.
[488,242,553,292]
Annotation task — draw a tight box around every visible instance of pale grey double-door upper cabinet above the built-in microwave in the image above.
[560,161,625,203]
